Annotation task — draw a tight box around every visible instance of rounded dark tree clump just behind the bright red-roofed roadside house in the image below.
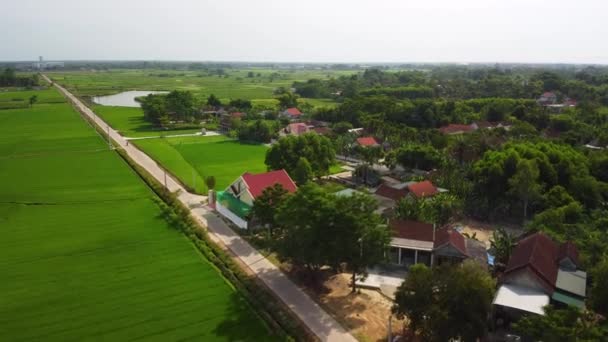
[265,133,335,178]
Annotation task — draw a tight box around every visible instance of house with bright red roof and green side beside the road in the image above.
[215,170,297,229]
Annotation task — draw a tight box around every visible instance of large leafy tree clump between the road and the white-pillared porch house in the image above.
[270,183,390,291]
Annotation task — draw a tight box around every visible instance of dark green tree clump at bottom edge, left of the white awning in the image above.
[392,260,496,341]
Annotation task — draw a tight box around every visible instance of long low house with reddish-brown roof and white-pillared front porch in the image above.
[389,219,487,267]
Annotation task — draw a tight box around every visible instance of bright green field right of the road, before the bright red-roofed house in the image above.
[133,136,267,194]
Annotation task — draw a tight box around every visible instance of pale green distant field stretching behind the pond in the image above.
[48,68,342,106]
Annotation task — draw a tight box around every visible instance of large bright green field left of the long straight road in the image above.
[0,89,273,341]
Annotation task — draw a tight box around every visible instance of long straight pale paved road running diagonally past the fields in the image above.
[43,75,356,341]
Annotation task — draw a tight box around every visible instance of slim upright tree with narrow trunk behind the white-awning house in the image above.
[509,159,542,220]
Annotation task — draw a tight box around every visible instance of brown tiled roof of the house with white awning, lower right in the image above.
[504,233,558,291]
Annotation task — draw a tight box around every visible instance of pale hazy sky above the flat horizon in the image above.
[0,0,608,64]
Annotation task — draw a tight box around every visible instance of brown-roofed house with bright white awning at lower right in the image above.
[493,232,587,318]
